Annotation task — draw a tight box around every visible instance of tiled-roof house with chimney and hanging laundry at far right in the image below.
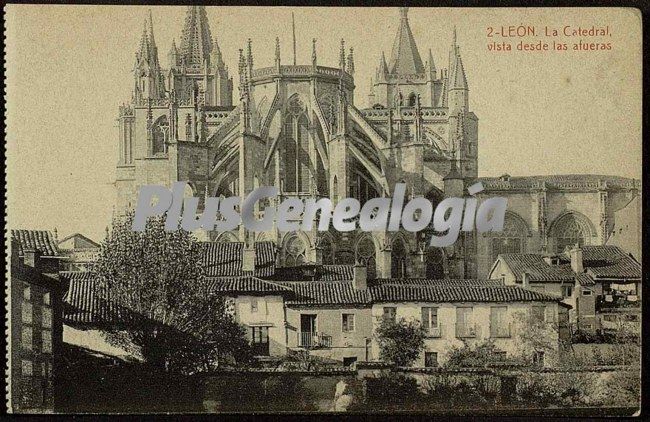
[489,245,642,332]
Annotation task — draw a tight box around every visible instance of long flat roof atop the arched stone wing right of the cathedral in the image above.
[476,174,639,190]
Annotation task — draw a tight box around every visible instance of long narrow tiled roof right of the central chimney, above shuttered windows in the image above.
[370,284,561,302]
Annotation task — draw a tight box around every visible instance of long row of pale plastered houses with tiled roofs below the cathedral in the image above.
[60,242,569,366]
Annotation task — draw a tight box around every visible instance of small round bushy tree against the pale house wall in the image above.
[375,318,425,366]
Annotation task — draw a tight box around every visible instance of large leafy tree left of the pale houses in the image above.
[94,212,252,372]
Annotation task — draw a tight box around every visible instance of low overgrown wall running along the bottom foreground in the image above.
[195,362,640,414]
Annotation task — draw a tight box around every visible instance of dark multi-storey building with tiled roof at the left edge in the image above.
[8,230,63,413]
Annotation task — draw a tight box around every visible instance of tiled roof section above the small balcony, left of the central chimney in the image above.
[282,281,370,305]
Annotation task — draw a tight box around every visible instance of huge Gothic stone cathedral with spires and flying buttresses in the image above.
[116,6,640,278]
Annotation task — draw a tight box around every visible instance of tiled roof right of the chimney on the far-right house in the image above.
[582,245,641,278]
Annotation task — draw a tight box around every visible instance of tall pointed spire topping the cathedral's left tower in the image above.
[180,6,212,67]
